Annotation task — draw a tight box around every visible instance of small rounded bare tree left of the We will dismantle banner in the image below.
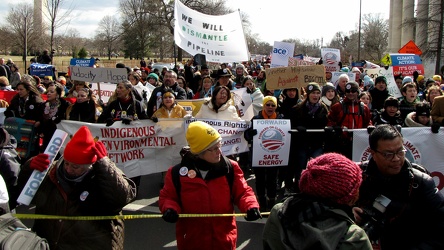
[96,16,121,60]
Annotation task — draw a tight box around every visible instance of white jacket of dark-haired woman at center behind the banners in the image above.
[196,100,241,121]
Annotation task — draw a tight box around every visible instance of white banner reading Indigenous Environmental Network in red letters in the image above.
[57,119,187,177]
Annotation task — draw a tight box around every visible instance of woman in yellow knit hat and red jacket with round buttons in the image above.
[159,121,262,250]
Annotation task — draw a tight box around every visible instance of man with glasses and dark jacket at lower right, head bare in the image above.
[353,124,444,250]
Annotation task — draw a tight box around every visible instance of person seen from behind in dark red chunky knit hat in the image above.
[263,153,373,250]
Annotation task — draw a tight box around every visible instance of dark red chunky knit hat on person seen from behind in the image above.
[299,153,362,205]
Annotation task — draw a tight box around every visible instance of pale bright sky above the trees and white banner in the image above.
[0,0,390,44]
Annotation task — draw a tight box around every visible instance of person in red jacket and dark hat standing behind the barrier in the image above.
[327,81,372,159]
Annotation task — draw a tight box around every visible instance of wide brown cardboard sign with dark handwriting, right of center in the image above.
[265,65,325,89]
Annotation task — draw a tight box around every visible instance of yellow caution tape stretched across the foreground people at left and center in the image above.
[13,212,270,220]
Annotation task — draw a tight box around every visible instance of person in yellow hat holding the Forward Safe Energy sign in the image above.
[244,96,283,211]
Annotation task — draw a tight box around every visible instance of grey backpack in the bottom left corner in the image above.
[0,213,49,250]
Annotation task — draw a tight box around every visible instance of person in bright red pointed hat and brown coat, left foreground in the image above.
[14,126,136,249]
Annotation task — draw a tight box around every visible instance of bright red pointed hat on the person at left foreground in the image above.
[63,126,97,164]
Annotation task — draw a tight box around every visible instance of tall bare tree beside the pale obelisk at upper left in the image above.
[42,0,74,57]
